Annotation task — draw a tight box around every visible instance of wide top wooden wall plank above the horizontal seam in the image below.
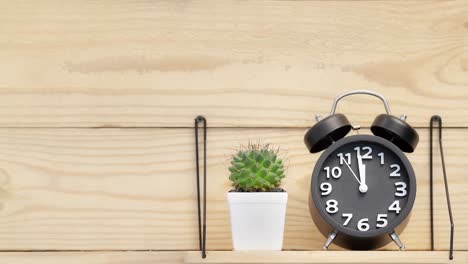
[0,0,468,127]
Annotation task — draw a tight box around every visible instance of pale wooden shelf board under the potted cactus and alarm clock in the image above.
[185,251,468,264]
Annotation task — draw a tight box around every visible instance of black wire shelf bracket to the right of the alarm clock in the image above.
[429,115,455,260]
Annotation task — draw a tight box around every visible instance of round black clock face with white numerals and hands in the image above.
[311,135,416,237]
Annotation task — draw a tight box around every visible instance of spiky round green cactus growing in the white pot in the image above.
[229,143,285,192]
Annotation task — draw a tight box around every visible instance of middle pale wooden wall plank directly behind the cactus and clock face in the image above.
[0,128,460,250]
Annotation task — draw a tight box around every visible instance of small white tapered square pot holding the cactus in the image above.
[227,192,288,250]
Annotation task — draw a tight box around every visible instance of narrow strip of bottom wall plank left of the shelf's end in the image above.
[0,251,185,264]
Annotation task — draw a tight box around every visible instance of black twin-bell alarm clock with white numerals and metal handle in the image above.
[304,90,419,250]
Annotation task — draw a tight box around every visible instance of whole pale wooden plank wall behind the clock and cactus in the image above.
[0,0,468,264]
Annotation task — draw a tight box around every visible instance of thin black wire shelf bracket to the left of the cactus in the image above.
[195,116,206,258]
